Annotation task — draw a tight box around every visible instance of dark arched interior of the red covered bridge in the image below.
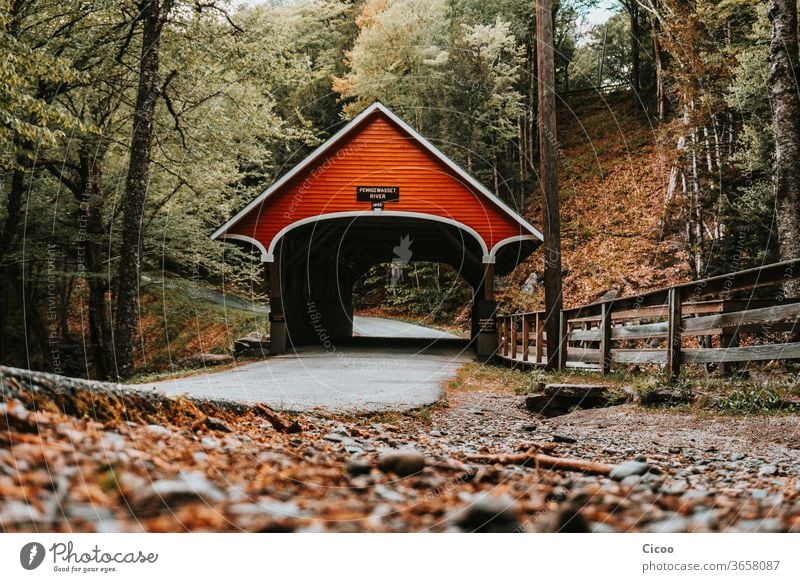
[270,215,537,349]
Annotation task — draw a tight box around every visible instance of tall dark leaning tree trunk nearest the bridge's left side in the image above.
[114,0,168,378]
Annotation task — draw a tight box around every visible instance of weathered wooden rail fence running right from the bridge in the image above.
[497,259,800,376]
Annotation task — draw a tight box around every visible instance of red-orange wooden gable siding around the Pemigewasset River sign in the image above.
[227,111,530,254]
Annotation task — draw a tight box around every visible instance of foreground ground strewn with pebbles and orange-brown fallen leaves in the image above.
[0,369,800,532]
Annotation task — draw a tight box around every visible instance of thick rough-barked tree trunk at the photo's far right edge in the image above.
[769,0,800,297]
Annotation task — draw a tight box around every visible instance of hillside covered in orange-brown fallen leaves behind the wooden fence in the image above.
[501,92,688,309]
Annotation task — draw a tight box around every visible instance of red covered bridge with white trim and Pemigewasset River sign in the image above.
[212,103,542,353]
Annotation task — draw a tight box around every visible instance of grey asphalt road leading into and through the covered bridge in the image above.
[138,317,473,412]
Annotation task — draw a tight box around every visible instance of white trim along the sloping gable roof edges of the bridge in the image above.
[211,101,544,242]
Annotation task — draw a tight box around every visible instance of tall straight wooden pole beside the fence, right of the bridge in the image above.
[536,0,566,370]
